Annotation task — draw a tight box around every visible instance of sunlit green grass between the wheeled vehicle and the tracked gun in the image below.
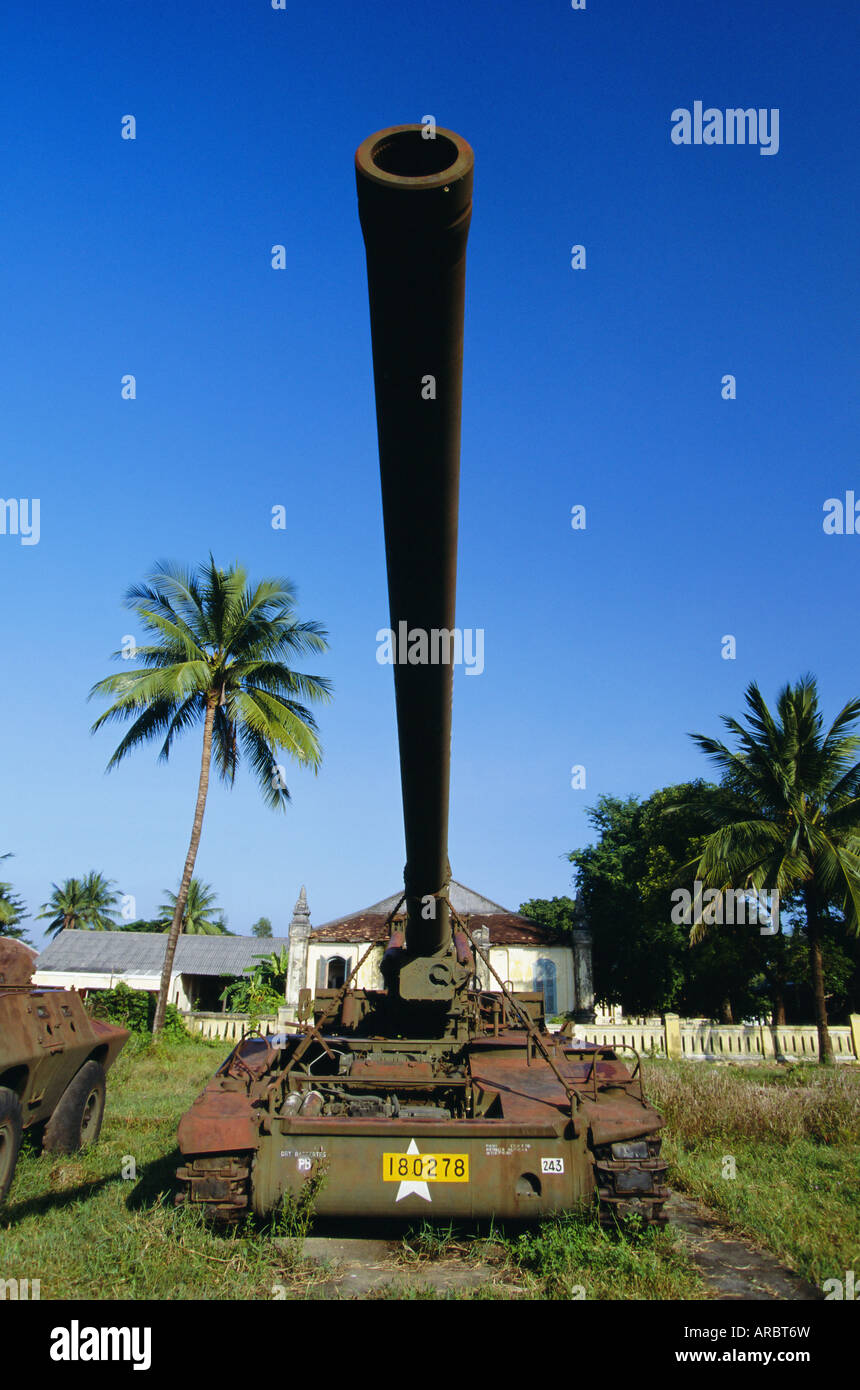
[0,1037,302,1300]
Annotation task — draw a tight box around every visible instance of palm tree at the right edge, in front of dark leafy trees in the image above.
[691,676,860,1065]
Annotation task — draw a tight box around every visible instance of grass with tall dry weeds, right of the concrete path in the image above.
[646,1062,860,1287]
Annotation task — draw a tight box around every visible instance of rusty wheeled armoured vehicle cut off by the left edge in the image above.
[0,937,128,1202]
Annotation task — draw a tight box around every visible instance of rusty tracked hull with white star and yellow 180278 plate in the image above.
[179,995,667,1222]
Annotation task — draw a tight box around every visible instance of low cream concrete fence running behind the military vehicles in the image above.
[185,1009,860,1062]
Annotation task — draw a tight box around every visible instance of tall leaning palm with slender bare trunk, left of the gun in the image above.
[90,556,331,1033]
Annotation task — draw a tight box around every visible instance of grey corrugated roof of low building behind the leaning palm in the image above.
[38,930,289,976]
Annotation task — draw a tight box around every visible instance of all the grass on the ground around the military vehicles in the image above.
[0,1037,860,1300]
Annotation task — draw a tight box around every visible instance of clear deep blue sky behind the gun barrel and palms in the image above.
[0,0,860,940]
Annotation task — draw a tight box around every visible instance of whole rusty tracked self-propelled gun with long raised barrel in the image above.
[176,125,667,1222]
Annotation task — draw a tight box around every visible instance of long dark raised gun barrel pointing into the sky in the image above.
[356,125,474,980]
